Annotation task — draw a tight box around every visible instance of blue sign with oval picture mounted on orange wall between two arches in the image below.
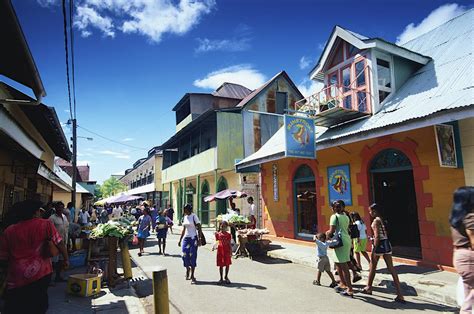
[328,165,352,206]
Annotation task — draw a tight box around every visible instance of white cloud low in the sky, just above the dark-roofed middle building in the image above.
[193,64,266,89]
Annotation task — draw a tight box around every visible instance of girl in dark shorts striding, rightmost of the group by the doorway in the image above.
[361,203,405,303]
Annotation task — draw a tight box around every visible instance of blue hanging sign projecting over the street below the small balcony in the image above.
[285,115,316,159]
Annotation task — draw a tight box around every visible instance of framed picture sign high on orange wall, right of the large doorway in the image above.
[434,124,458,168]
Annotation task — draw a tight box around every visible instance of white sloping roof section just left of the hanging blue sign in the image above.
[235,127,285,170]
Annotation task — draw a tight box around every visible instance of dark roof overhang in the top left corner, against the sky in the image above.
[0,0,46,100]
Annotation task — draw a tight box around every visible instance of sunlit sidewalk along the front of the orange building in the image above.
[266,236,459,307]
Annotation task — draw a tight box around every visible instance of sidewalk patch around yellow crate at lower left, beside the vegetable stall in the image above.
[47,267,146,314]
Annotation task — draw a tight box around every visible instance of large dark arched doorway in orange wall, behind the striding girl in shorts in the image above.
[370,149,421,258]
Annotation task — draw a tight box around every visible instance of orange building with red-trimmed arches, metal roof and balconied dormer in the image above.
[237,10,474,266]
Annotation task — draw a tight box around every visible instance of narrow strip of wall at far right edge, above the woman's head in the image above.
[459,118,474,186]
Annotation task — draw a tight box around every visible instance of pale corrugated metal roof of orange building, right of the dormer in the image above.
[317,9,474,142]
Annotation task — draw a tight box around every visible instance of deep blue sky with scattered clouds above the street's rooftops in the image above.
[12,0,472,182]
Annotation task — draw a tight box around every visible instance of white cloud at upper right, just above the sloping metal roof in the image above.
[396,3,466,45]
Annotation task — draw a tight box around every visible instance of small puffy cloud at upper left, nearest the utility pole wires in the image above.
[74,4,115,37]
